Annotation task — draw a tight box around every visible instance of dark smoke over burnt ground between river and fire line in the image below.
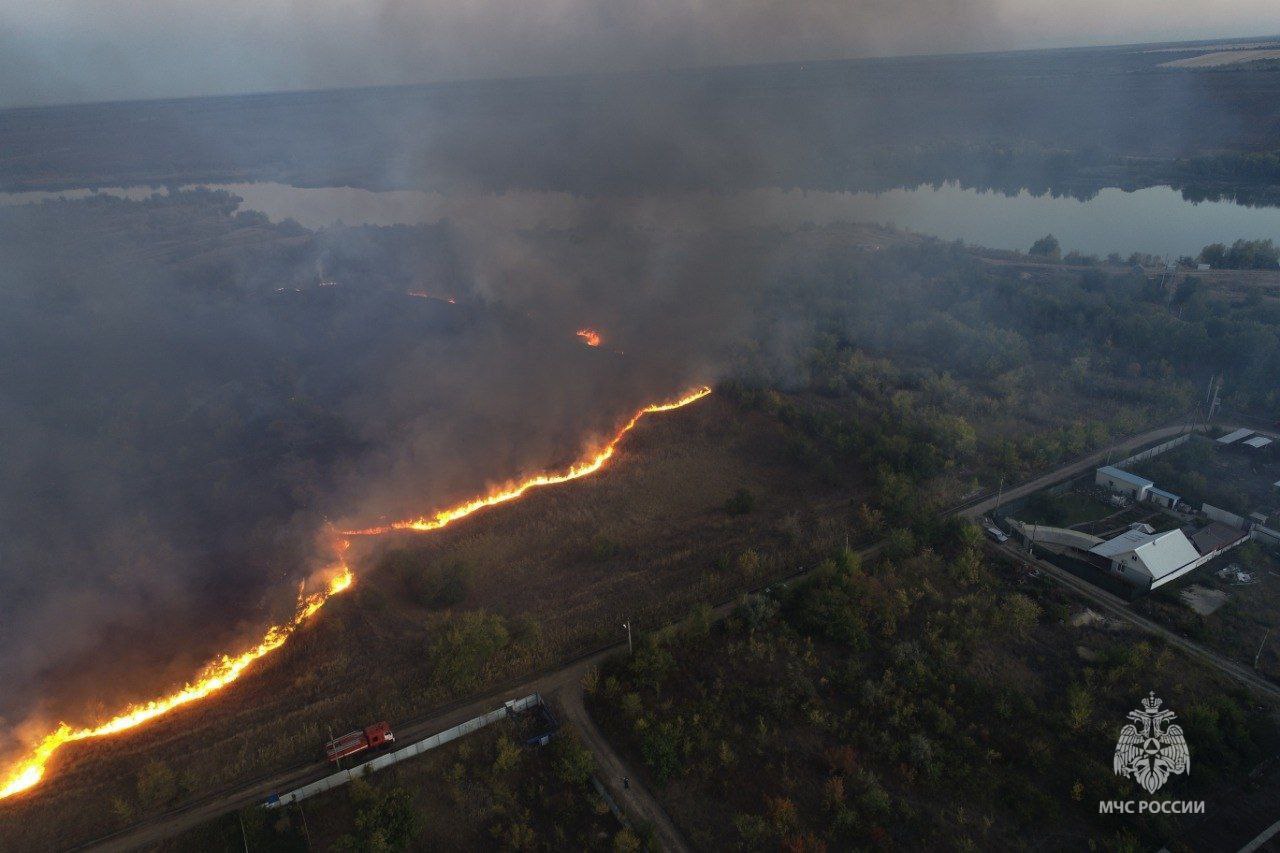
[0,175,759,725]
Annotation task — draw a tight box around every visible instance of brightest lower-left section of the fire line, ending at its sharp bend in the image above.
[0,565,356,799]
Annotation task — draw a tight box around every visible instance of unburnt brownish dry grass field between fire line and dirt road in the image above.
[0,396,858,850]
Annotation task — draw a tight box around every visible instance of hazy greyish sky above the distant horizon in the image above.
[0,0,1280,105]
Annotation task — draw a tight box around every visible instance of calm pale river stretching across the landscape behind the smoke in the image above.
[10,183,1280,257]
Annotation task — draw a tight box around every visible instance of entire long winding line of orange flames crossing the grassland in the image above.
[0,386,712,799]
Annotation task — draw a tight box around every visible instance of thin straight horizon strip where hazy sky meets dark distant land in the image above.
[0,31,1280,113]
